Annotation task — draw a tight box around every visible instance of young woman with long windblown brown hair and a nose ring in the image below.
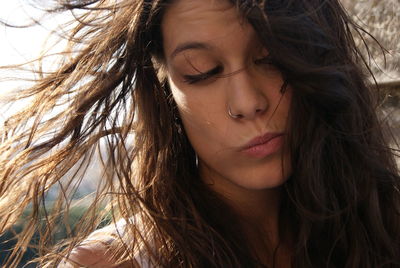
[0,0,400,268]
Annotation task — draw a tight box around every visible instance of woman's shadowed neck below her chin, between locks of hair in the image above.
[201,165,290,267]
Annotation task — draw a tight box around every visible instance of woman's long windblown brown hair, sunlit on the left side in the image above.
[0,0,400,268]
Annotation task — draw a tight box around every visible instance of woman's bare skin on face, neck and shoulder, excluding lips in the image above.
[64,0,291,267]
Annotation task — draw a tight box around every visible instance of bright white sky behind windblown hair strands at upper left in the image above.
[0,0,68,123]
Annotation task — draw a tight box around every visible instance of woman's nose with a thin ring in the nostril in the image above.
[227,69,268,120]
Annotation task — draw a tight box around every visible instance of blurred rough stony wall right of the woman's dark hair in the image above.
[342,0,400,138]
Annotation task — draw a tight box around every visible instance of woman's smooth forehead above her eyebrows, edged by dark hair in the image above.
[161,0,251,55]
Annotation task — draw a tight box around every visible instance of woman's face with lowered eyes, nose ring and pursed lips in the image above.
[162,0,291,195]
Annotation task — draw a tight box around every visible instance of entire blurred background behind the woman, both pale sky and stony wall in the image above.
[0,0,400,267]
